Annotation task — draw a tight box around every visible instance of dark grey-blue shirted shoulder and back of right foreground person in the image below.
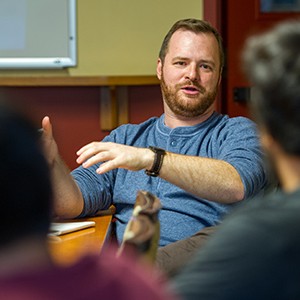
[173,190,300,300]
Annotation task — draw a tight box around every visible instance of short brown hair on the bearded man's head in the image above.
[159,19,224,70]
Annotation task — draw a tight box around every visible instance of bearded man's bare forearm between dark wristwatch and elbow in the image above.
[160,152,244,203]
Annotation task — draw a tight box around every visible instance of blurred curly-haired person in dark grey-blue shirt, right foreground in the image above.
[174,21,300,300]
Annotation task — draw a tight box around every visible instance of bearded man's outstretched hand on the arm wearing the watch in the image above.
[76,142,154,174]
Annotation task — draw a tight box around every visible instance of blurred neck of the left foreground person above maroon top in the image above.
[0,238,52,278]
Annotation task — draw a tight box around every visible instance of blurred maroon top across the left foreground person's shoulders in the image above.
[0,250,177,300]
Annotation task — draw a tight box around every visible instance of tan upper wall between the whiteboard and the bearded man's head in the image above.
[0,0,203,76]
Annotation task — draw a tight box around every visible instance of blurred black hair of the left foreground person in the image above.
[0,103,52,247]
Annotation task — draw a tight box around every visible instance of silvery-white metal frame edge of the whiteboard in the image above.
[0,0,77,69]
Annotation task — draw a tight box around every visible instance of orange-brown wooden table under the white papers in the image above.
[49,215,112,265]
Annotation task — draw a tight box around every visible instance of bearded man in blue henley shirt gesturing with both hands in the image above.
[42,19,266,276]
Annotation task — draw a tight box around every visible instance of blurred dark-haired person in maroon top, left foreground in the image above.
[0,104,175,300]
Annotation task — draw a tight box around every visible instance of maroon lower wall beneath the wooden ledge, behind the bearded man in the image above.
[0,85,162,169]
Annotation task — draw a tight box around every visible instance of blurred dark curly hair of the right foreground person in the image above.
[243,20,300,155]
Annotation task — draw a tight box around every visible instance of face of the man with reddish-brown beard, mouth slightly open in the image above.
[157,30,220,118]
